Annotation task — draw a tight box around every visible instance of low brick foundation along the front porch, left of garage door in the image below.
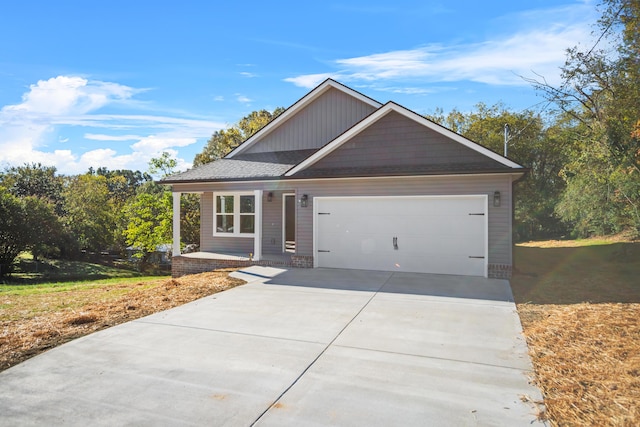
[171,255,313,278]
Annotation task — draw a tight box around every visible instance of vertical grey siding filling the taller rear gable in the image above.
[245,88,375,153]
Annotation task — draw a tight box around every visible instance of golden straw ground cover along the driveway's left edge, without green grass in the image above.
[0,270,245,371]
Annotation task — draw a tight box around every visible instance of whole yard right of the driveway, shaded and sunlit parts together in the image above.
[511,239,640,426]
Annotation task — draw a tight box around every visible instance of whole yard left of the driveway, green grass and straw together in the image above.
[0,264,244,371]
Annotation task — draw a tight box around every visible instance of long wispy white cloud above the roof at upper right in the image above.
[285,4,593,91]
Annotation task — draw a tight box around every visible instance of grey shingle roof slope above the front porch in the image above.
[161,149,317,184]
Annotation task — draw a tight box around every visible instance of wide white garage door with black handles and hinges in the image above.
[314,195,487,277]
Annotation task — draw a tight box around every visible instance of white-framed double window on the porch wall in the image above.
[214,193,256,237]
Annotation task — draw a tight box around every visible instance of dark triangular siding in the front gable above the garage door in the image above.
[308,111,498,171]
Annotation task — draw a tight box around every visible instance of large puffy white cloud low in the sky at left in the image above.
[0,76,225,174]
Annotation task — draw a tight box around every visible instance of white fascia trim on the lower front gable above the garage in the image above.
[285,102,522,176]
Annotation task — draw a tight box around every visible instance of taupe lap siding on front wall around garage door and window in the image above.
[179,174,514,265]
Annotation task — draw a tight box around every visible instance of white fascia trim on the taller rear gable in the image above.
[225,79,382,159]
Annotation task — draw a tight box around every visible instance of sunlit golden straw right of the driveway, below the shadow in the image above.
[518,303,640,426]
